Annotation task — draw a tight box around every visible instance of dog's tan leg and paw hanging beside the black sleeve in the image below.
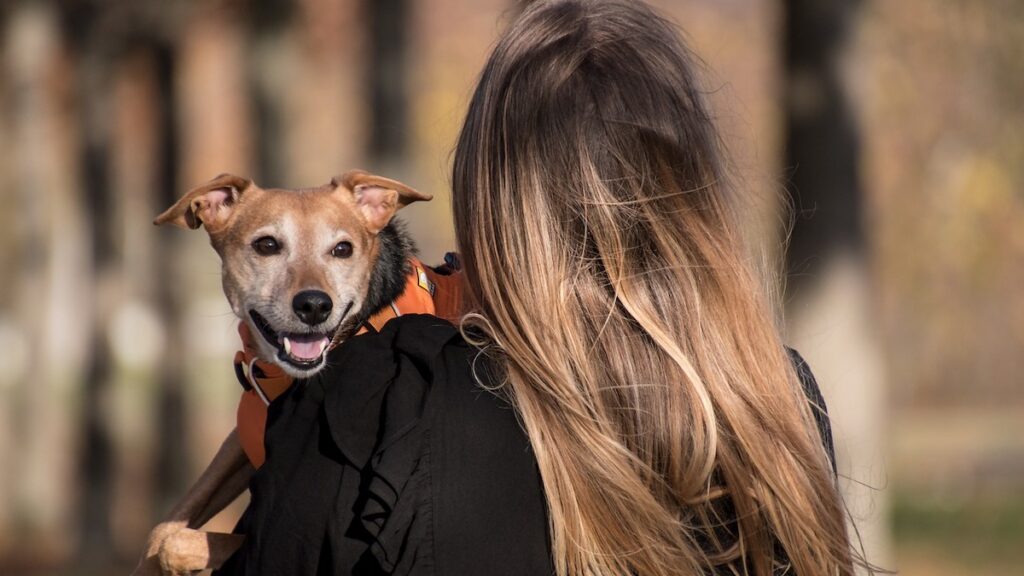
[132,430,254,576]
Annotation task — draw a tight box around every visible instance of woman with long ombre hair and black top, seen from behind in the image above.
[224,0,854,576]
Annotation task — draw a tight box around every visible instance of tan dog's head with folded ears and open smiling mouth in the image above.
[154,170,431,377]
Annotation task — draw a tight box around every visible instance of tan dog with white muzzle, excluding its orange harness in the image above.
[134,170,431,576]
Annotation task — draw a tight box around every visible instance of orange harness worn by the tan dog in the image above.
[234,256,462,468]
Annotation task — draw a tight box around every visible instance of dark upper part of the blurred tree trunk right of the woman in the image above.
[783,0,864,284]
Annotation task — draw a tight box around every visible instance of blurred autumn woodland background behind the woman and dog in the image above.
[0,0,1024,576]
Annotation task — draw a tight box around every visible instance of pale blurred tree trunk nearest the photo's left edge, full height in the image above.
[6,3,75,553]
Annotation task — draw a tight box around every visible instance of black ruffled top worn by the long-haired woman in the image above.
[216,315,831,576]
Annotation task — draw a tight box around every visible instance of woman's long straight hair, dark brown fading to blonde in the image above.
[453,0,853,576]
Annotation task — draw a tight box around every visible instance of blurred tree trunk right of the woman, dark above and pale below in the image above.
[783,0,888,564]
